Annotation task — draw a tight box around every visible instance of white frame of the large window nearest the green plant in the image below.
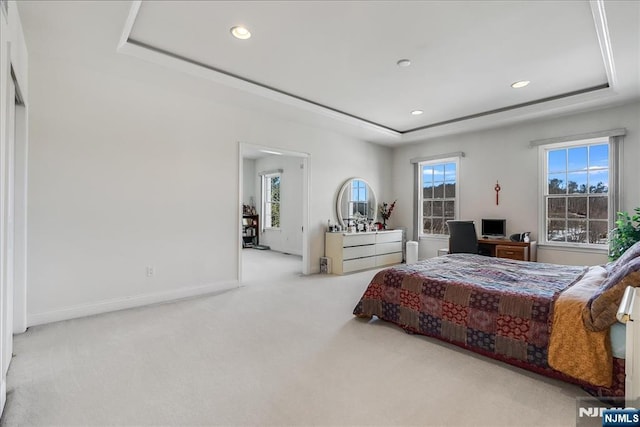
[538,136,620,252]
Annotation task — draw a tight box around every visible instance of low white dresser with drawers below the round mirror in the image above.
[325,230,402,274]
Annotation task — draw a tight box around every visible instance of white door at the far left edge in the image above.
[0,71,15,414]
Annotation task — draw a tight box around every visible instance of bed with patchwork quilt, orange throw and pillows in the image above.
[353,244,640,397]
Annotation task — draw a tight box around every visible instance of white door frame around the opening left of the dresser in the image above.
[236,142,311,284]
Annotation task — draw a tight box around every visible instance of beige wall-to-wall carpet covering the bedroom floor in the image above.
[2,250,585,426]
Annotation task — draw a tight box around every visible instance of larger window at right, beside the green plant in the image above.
[540,138,616,247]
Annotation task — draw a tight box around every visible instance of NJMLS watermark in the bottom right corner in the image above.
[576,397,640,427]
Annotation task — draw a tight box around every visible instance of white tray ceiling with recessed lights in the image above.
[19,1,640,146]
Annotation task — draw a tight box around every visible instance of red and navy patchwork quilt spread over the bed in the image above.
[353,254,624,396]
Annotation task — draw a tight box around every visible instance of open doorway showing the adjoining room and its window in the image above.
[238,143,310,284]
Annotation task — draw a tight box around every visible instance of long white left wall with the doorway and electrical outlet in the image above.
[28,6,390,325]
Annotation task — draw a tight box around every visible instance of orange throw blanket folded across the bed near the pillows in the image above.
[549,267,613,387]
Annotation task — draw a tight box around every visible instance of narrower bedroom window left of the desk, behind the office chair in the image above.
[418,158,458,235]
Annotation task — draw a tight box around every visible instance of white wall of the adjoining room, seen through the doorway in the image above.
[254,156,304,256]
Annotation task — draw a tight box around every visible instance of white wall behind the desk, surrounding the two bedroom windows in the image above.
[393,103,640,264]
